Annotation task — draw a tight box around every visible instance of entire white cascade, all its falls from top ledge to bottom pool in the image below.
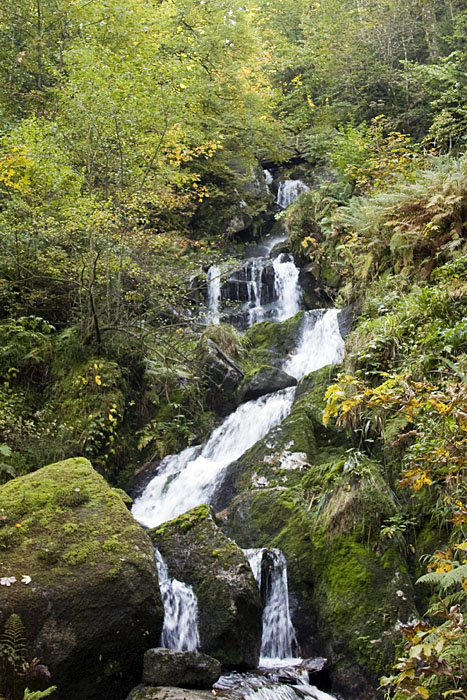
[133,172,344,700]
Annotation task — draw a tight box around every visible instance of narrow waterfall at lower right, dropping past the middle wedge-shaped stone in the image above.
[243,549,297,666]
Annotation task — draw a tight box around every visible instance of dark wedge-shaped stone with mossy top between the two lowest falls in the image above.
[154,505,262,669]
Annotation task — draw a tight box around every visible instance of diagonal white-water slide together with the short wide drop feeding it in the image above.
[132,310,344,527]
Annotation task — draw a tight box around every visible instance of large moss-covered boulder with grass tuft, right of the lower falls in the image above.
[225,448,415,699]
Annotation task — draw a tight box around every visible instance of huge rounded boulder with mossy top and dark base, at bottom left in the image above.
[0,457,163,700]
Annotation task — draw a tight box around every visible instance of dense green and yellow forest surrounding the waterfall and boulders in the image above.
[0,0,467,700]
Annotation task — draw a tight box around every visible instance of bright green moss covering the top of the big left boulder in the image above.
[0,457,158,585]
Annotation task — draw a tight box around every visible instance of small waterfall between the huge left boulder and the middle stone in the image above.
[155,548,199,651]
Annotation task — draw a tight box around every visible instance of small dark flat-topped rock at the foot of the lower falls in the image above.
[143,648,221,688]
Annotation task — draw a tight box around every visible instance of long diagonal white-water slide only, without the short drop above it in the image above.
[132,388,294,527]
